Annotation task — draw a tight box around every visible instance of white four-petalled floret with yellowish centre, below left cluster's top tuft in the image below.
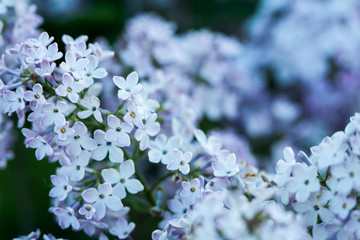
[55,73,84,103]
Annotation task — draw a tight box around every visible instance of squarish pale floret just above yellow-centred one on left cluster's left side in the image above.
[41,101,68,126]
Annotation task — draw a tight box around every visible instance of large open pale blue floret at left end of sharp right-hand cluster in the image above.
[285,163,320,203]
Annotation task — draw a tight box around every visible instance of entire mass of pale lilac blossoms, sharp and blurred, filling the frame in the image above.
[0,0,360,240]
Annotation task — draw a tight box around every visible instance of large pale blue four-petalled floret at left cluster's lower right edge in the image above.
[101,160,144,199]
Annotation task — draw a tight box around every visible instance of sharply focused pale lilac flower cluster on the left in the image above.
[1,26,164,238]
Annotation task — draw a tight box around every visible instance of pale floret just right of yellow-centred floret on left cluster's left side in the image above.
[59,122,97,156]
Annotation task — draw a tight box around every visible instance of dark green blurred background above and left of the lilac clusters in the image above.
[0,0,258,240]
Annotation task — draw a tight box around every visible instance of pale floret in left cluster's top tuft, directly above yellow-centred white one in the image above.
[60,51,89,79]
